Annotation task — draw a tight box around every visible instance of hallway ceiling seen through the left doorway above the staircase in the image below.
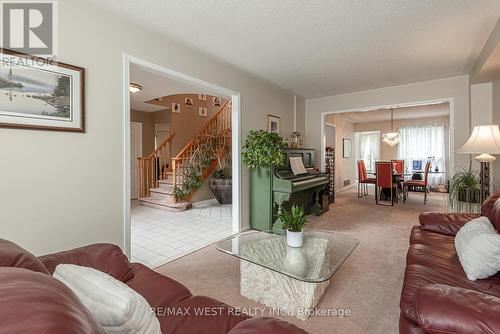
[130,64,220,112]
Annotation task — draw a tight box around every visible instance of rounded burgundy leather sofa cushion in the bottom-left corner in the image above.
[0,268,105,334]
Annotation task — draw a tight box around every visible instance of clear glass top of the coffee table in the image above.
[217,230,359,283]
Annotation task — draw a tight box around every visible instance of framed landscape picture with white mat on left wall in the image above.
[0,49,85,132]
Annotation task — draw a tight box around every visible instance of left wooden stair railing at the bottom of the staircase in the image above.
[138,133,175,197]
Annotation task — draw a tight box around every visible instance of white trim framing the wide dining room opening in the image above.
[320,97,455,175]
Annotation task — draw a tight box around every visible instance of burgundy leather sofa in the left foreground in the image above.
[0,239,307,334]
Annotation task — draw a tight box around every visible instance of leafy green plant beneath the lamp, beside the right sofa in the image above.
[448,165,481,211]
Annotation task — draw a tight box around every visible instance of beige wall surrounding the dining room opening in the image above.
[306,76,470,175]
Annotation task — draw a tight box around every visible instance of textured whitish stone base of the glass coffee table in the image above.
[240,260,330,320]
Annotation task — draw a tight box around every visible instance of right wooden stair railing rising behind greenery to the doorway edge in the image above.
[171,101,231,201]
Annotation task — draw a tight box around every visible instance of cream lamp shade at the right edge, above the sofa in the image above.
[457,125,500,154]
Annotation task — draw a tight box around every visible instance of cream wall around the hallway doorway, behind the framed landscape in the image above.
[0,0,304,254]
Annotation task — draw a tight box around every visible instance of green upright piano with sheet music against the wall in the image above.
[250,148,328,231]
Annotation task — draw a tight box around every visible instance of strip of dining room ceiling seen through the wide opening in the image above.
[339,103,450,123]
